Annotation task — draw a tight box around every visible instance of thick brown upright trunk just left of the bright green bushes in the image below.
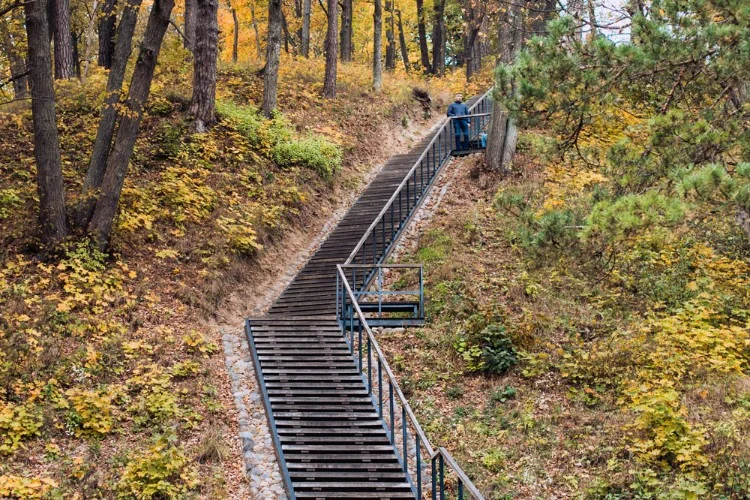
[190,0,219,133]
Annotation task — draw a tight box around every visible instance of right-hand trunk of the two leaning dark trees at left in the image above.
[89,0,174,248]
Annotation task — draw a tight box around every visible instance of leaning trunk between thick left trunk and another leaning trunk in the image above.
[75,0,141,229]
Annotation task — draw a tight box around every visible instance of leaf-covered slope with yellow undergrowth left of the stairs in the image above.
[0,42,494,497]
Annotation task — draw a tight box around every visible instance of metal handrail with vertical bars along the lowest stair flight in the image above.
[336,264,484,500]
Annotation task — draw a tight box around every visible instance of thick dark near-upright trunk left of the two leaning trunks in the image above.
[24,0,70,244]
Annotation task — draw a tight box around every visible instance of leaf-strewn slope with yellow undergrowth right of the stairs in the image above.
[381,118,750,498]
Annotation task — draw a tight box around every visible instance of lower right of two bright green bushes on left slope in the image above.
[272,136,342,179]
